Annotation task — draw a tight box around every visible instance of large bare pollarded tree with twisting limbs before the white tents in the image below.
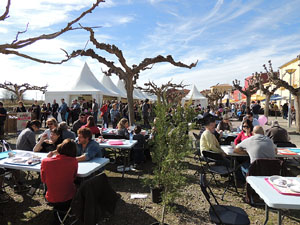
[71,27,197,124]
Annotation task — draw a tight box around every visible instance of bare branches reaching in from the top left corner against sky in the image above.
[0,0,104,64]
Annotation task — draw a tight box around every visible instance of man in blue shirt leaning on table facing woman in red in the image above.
[76,127,103,162]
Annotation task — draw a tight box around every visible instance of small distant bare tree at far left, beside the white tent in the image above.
[0,81,48,101]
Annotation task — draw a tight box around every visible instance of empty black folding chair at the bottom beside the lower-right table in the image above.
[200,174,250,225]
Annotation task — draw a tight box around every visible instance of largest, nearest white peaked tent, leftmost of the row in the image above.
[45,63,118,105]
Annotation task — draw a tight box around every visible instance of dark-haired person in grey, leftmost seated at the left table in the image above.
[16,120,41,151]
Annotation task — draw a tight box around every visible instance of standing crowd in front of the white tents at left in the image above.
[14,99,153,128]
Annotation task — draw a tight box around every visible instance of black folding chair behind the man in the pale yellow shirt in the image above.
[202,151,238,200]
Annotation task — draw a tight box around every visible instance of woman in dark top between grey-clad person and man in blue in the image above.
[33,128,62,153]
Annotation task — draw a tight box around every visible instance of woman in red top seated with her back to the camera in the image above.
[41,139,78,220]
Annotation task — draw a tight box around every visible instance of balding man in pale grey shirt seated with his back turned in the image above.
[234,126,277,175]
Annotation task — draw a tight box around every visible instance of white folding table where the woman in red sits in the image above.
[0,150,109,177]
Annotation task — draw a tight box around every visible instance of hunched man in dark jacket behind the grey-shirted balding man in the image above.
[266,120,296,147]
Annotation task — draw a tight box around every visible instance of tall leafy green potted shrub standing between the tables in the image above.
[146,104,193,225]
